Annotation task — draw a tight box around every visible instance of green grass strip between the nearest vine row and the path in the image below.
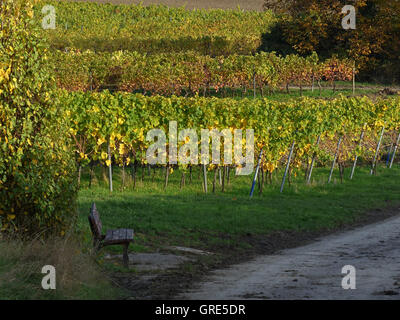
[79,167,400,251]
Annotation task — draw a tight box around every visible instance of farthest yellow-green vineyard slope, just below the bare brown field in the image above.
[35,0,275,56]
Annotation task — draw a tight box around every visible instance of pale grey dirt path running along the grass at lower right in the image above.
[179,215,400,300]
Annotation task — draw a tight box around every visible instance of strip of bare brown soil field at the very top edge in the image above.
[67,0,264,11]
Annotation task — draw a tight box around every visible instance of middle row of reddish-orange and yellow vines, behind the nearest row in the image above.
[51,50,354,96]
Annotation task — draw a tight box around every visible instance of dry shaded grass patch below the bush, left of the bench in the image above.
[0,236,124,300]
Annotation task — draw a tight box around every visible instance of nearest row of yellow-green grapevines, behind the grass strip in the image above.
[63,92,400,192]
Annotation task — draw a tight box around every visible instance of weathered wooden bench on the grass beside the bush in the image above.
[89,202,133,267]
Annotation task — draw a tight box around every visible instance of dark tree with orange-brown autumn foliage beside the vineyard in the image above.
[263,0,400,81]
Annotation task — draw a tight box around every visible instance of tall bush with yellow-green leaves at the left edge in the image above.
[0,0,77,235]
